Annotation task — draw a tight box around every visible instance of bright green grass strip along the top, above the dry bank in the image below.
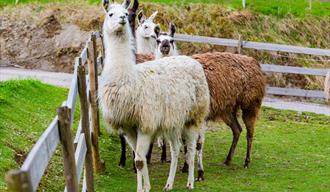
[0,0,330,17]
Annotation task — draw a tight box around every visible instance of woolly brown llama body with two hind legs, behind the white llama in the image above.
[137,52,266,167]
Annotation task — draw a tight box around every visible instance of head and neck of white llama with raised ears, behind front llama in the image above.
[135,11,160,54]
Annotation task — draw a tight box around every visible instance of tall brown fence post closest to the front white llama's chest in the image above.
[87,34,104,173]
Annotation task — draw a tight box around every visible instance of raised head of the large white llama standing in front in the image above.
[102,0,130,35]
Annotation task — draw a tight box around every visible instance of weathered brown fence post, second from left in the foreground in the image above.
[57,106,79,192]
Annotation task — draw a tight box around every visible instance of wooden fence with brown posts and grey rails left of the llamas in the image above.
[6,33,104,192]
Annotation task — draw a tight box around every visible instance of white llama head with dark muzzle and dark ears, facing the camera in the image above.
[155,23,177,58]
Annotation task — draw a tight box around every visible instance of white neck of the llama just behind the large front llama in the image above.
[136,33,156,54]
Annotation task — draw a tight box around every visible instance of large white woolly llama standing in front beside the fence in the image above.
[99,0,210,191]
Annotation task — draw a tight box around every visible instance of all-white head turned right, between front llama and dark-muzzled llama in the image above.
[137,11,160,39]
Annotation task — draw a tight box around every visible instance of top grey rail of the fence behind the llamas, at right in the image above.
[175,34,330,57]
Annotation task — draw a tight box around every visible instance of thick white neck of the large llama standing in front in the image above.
[102,30,136,76]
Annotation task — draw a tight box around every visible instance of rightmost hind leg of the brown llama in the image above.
[242,105,260,168]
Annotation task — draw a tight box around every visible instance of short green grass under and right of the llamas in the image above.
[97,108,330,192]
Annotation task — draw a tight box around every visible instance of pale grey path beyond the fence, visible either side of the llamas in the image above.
[0,67,330,116]
